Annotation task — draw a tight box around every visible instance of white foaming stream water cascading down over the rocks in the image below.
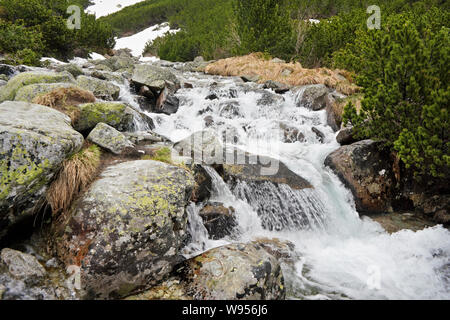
[118,67,450,299]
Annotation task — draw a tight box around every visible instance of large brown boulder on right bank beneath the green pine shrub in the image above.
[325,140,396,214]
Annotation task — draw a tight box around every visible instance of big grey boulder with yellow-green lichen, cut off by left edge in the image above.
[0,101,83,238]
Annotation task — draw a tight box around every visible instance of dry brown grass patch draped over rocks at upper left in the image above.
[33,88,95,123]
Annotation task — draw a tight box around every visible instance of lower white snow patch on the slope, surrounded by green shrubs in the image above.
[114,22,178,57]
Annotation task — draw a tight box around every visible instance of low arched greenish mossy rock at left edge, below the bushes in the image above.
[0,71,75,102]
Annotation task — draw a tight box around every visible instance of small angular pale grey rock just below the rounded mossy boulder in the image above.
[87,122,137,155]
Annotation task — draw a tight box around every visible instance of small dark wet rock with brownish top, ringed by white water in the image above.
[199,202,237,240]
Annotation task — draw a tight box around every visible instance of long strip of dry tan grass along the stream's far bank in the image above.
[205,53,360,95]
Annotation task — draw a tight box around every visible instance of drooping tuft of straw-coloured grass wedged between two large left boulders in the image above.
[46,145,101,216]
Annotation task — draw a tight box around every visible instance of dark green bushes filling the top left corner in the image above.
[0,0,114,65]
